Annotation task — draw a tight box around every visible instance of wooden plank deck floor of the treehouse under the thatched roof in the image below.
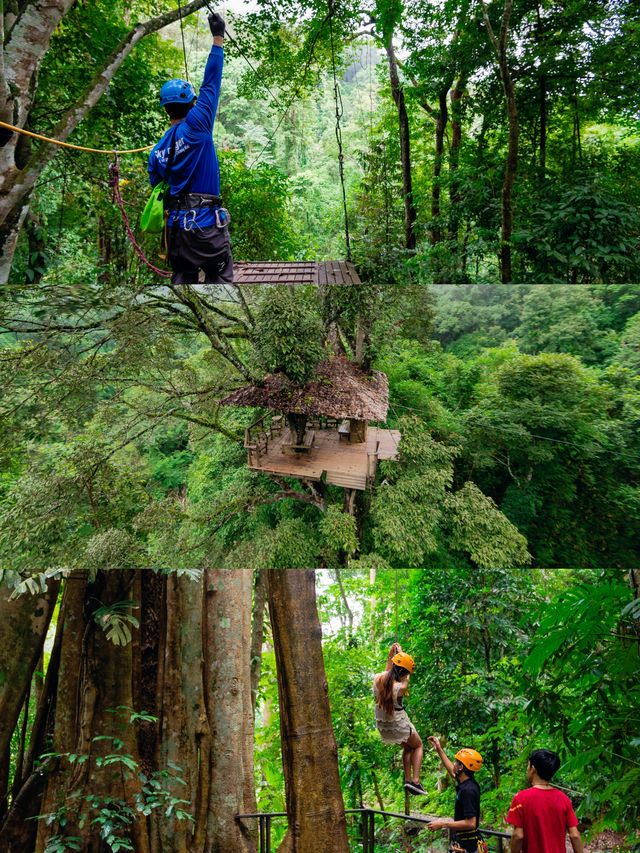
[249,427,400,491]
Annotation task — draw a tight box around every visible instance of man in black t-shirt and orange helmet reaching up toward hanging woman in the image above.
[428,737,482,853]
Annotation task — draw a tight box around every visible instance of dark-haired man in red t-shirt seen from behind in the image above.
[507,749,583,853]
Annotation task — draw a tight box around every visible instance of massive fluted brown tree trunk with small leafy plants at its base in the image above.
[0,570,264,853]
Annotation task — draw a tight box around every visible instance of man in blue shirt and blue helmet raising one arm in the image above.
[148,13,233,284]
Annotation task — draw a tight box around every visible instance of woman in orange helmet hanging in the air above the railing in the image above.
[373,643,426,794]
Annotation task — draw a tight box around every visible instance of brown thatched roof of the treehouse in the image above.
[220,356,389,421]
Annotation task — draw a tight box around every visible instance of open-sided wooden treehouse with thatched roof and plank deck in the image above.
[221,356,400,490]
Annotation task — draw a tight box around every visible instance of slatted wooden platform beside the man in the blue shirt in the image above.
[233,261,360,284]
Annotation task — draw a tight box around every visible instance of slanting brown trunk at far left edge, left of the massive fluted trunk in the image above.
[0,581,60,812]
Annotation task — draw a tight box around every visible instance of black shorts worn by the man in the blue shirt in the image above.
[168,225,233,284]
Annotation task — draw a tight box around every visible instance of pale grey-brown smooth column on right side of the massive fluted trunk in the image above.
[204,569,253,853]
